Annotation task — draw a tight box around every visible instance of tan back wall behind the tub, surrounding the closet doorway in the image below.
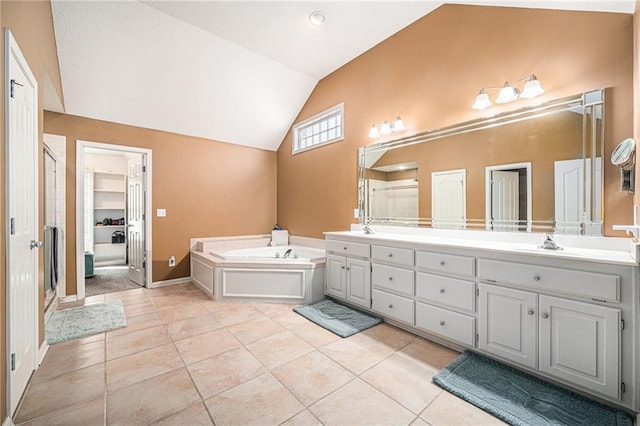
[44,111,276,294]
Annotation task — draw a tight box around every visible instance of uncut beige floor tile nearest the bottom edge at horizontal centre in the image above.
[272,351,356,408]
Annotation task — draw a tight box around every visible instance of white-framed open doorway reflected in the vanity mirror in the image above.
[485,162,532,231]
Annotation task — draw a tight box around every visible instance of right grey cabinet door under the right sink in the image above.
[539,296,620,399]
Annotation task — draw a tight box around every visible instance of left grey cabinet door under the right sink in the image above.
[478,284,538,368]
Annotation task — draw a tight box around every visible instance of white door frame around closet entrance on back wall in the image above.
[76,140,153,299]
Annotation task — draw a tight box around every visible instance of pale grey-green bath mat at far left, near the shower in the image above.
[45,300,127,345]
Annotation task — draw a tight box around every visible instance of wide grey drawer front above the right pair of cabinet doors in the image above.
[478,259,620,302]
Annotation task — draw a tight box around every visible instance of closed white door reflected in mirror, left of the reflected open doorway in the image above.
[431,170,467,228]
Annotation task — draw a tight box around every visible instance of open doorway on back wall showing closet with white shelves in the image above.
[76,141,151,298]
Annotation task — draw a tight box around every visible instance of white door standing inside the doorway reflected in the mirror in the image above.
[491,170,520,231]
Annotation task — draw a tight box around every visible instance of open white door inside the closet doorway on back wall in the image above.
[127,155,146,286]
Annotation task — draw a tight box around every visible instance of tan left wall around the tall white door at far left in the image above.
[0,1,62,419]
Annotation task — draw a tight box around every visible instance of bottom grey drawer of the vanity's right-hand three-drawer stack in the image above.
[416,302,475,347]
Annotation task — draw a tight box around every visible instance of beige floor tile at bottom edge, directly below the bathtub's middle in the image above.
[205,373,304,425]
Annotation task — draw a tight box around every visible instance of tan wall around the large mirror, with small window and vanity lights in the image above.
[278,5,633,237]
